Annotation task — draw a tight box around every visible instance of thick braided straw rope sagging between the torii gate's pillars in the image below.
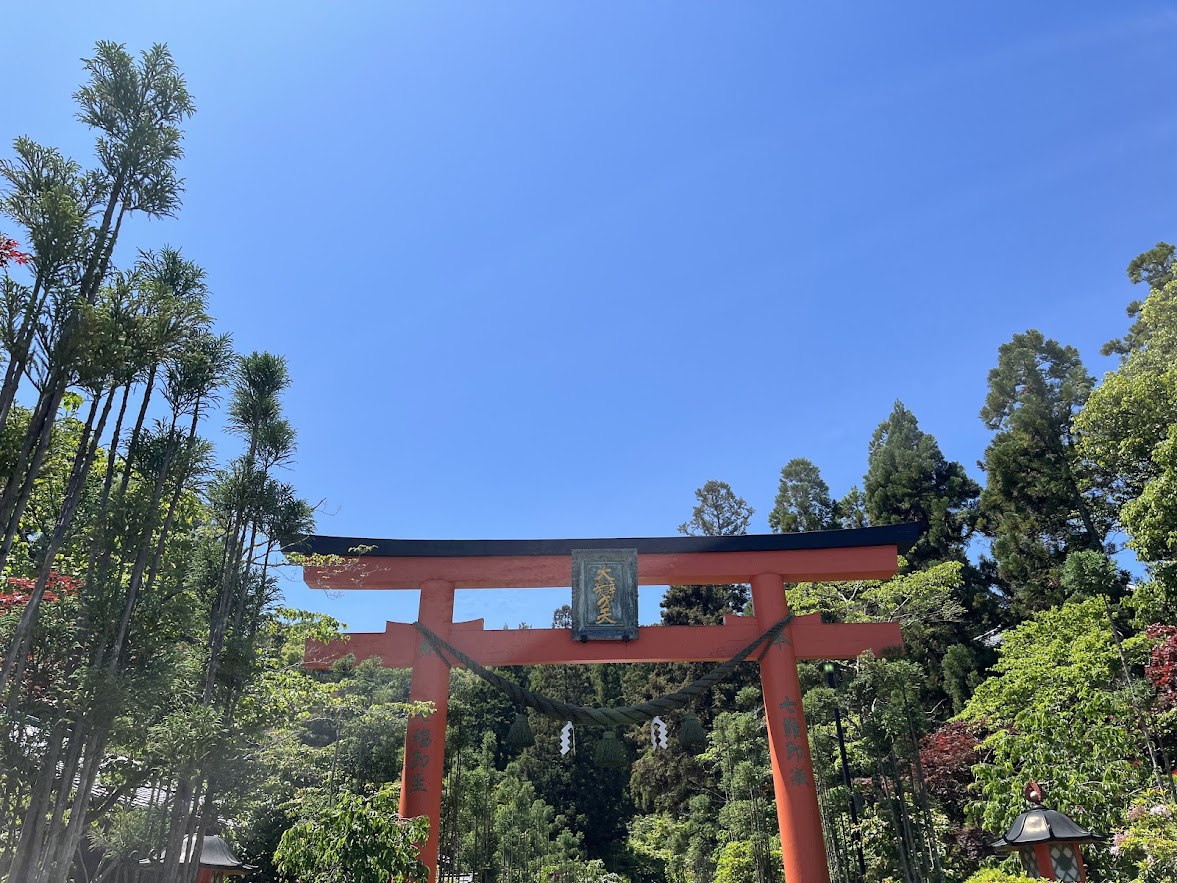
[413,613,793,726]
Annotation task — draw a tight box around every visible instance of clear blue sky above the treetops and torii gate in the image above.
[0,0,1177,630]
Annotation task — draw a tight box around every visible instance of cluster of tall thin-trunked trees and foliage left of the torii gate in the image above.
[0,48,335,883]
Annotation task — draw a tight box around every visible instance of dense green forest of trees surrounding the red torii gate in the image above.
[0,42,1177,883]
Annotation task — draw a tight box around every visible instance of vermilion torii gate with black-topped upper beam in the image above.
[296,524,919,883]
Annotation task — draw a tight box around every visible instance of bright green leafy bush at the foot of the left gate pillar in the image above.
[274,788,428,883]
